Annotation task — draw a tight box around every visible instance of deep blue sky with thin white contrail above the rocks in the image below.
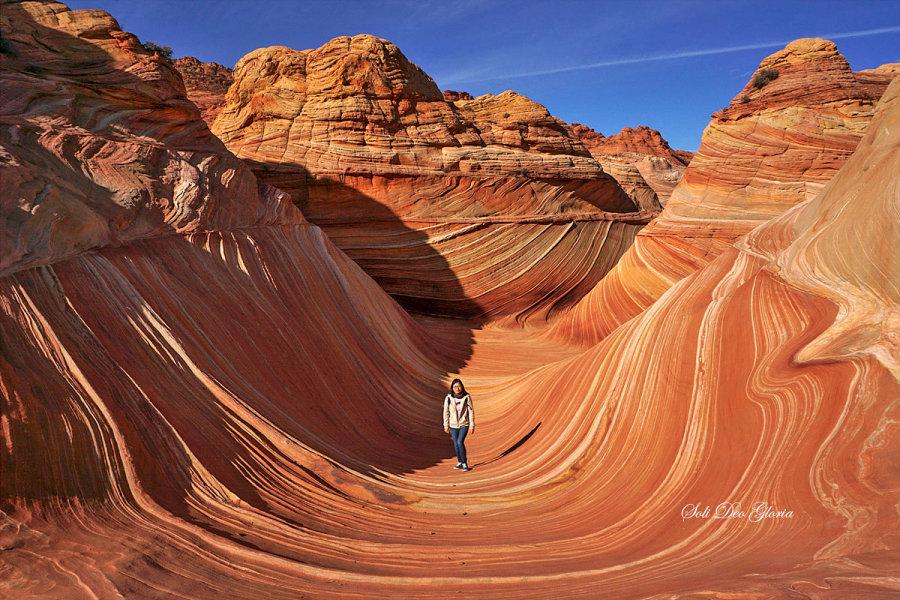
[68,0,900,150]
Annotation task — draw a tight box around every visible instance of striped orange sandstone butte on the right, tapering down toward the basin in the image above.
[555,38,893,344]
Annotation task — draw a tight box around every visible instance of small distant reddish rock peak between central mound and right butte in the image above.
[571,123,693,204]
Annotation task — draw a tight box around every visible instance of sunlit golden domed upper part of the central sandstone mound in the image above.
[214,35,608,178]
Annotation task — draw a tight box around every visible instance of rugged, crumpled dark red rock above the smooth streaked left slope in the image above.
[0,3,302,274]
